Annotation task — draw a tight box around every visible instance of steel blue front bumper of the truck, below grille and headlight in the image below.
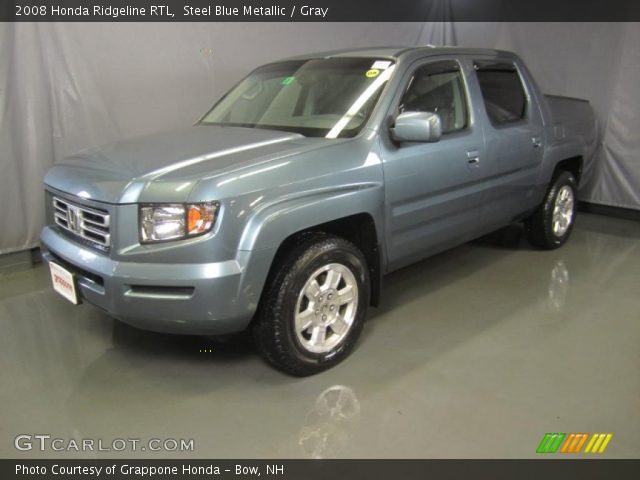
[40,227,269,335]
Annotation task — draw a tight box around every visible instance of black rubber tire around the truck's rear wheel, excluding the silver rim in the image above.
[524,171,577,250]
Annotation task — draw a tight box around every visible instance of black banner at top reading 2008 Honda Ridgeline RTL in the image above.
[0,0,640,22]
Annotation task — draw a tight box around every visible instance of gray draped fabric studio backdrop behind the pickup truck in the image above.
[0,22,640,254]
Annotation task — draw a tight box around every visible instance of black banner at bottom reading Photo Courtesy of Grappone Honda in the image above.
[0,459,640,480]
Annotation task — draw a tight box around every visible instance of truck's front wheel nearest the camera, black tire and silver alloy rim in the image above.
[253,234,370,376]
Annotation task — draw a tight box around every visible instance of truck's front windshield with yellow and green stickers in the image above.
[200,58,394,138]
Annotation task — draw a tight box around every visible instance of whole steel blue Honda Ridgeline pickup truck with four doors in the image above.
[41,47,596,376]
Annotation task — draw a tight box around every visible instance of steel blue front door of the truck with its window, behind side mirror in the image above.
[380,56,484,269]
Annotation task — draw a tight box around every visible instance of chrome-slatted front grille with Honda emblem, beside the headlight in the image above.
[53,197,111,249]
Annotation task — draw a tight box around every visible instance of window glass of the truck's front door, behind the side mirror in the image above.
[398,61,468,134]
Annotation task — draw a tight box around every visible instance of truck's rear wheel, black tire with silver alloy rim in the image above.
[524,172,577,250]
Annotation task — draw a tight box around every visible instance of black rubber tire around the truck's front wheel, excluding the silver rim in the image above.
[252,233,370,377]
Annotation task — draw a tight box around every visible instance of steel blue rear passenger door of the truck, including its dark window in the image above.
[471,58,544,231]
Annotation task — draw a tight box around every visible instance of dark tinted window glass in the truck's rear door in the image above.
[475,62,527,125]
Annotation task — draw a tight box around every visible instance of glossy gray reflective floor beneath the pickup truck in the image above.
[0,214,640,458]
